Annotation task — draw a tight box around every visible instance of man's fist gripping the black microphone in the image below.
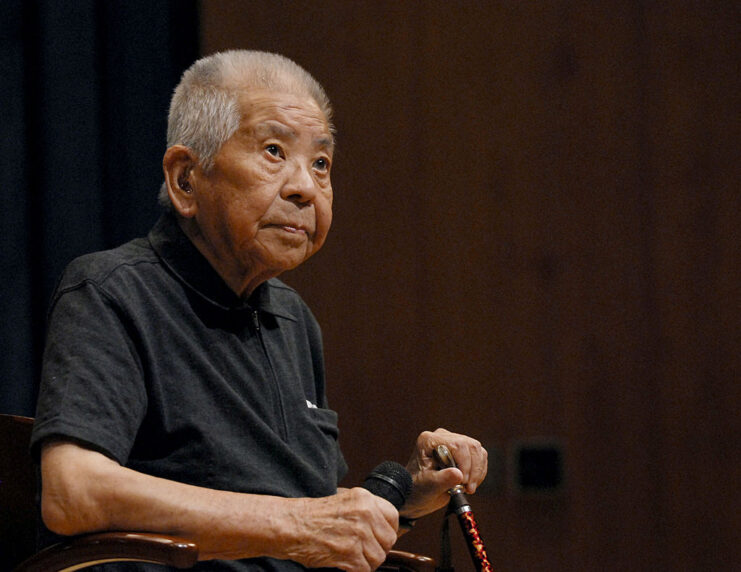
[288,488,399,572]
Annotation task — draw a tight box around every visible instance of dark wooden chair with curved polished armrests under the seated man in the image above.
[0,414,435,572]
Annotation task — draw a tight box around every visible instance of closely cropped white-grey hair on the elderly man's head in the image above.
[159,50,334,208]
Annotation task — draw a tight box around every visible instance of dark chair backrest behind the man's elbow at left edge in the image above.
[0,414,37,570]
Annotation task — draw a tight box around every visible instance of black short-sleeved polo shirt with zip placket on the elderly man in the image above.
[32,215,347,569]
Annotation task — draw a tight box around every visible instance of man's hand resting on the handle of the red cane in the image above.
[402,429,488,518]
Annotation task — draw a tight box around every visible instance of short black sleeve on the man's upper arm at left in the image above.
[31,281,147,464]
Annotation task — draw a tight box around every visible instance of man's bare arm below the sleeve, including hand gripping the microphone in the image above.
[41,441,398,572]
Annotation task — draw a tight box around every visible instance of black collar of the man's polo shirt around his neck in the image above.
[148,213,296,320]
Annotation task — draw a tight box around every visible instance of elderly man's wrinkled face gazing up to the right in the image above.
[195,91,333,293]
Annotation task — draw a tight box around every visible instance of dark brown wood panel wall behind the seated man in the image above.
[202,0,741,572]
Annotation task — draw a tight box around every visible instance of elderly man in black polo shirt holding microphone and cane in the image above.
[33,51,486,570]
